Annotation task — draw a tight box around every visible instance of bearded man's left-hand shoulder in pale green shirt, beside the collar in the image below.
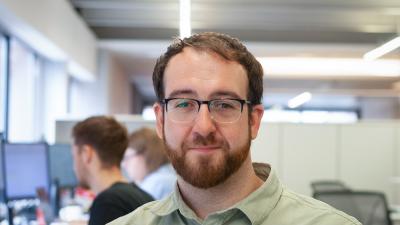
[107,200,164,225]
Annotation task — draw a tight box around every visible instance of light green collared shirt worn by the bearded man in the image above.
[107,163,361,225]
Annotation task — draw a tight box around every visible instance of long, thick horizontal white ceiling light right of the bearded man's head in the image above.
[257,57,400,77]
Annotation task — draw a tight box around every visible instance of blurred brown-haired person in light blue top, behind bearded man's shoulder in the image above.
[121,127,176,199]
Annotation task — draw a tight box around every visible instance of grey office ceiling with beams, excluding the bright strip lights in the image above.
[71,0,400,108]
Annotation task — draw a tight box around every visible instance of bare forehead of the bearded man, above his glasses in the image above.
[164,48,248,98]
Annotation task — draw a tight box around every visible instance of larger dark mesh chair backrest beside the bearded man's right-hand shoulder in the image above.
[314,191,392,225]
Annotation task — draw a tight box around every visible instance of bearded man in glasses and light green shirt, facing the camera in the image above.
[110,33,360,225]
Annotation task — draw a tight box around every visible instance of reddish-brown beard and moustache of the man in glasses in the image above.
[163,129,251,189]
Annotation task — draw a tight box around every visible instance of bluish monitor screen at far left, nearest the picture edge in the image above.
[3,143,50,200]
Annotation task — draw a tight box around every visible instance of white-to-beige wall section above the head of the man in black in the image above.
[70,50,132,118]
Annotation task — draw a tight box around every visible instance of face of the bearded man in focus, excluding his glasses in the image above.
[154,48,263,188]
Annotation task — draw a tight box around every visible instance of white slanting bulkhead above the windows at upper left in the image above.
[0,0,97,80]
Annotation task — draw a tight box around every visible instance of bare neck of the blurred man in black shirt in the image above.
[90,167,127,195]
